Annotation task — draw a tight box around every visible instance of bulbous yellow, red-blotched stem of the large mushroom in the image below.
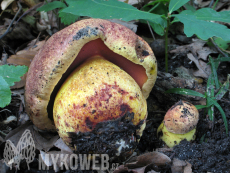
[53,57,147,153]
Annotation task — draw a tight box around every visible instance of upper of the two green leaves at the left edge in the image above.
[0,65,28,86]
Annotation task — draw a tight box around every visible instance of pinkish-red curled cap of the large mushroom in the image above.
[25,19,157,131]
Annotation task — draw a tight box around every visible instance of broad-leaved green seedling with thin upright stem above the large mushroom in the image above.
[38,0,230,72]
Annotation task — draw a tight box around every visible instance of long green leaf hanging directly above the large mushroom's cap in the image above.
[62,0,164,24]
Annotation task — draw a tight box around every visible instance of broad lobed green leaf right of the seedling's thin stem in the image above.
[172,10,230,41]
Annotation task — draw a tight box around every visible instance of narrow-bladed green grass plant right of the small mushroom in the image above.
[166,57,230,134]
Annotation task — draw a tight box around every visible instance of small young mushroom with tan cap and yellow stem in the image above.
[157,100,199,148]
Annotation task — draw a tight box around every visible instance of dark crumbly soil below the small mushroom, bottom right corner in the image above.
[173,137,230,173]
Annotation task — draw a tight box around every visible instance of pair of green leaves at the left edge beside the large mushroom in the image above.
[0,65,28,108]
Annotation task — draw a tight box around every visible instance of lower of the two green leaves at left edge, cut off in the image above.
[0,76,11,108]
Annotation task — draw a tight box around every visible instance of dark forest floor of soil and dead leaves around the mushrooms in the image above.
[0,1,230,173]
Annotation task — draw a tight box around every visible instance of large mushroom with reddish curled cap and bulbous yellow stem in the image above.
[25,19,157,158]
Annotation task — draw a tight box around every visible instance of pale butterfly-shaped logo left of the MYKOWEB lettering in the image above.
[3,129,35,170]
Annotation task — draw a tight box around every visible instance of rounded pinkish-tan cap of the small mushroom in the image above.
[164,100,199,134]
